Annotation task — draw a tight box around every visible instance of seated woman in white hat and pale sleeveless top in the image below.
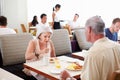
[23,26,56,80]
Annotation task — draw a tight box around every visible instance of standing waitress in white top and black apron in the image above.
[52,4,61,29]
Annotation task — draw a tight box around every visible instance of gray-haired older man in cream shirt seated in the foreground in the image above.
[61,16,120,80]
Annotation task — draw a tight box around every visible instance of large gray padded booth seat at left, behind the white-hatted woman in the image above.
[0,33,36,80]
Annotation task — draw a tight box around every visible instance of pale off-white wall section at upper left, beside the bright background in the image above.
[2,0,27,32]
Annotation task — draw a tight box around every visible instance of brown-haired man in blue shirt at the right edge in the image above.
[105,18,120,41]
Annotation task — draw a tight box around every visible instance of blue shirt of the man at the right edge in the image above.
[105,28,118,41]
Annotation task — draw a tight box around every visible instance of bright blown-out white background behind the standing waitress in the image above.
[28,0,120,27]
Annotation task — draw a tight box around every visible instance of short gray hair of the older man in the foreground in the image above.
[85,16,105,34]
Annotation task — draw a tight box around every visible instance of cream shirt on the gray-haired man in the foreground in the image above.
[81,37,120,80]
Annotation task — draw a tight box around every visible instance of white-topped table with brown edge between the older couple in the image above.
[24,56,84,80]
